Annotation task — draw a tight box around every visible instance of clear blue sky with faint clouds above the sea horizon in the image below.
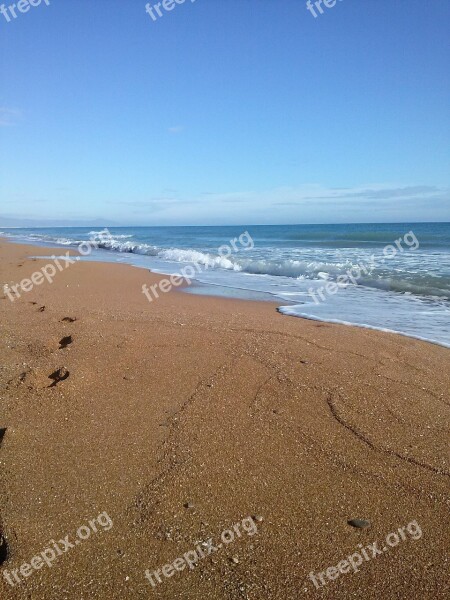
[0,0,450,227]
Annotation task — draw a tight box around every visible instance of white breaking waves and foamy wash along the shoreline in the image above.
[3,231,450,347]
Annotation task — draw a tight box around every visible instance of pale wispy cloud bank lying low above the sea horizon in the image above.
[0,182,450,225]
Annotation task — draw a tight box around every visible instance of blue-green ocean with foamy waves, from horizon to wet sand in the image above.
[2,223,450,348]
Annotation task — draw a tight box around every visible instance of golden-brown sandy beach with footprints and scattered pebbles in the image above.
[0,239,450,600]
